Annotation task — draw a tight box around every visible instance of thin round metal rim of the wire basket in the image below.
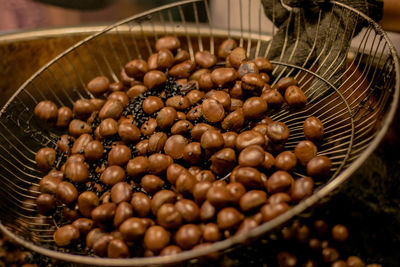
[0,0,400,266]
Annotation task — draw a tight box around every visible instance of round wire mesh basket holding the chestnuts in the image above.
[0,0,400,266]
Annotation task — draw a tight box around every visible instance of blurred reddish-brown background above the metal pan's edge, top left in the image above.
[0,0,164,32]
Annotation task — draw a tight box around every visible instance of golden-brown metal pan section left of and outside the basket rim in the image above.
[0,25,106,107]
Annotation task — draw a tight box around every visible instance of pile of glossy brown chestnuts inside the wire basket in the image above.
[34,36,332,258]
